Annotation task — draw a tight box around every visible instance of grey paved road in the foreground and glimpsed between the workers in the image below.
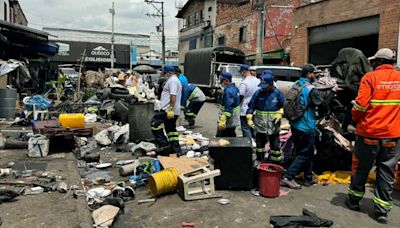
[115,103,400,228]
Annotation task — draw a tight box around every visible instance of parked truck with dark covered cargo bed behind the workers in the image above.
[184,47,245,99]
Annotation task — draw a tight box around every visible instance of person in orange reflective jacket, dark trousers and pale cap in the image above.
[346,48,400,224]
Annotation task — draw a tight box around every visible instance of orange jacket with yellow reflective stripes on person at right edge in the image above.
[352,64,400,138]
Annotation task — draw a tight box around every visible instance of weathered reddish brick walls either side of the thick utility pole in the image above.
[215,0,293,55]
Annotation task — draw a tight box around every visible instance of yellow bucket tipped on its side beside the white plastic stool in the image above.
[149,168,179,196]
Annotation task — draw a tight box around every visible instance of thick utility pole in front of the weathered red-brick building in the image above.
[255,0,265,66]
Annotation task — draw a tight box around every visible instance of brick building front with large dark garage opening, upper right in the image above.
[291,0,400,65]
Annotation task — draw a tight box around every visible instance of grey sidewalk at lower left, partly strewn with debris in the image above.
[0,150,93,228]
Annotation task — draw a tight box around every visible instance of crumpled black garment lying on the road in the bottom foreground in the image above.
[269,208,333,228]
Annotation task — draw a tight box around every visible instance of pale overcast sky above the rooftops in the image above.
[19,0,186,50]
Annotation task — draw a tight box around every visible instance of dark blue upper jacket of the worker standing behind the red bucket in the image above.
[246,87,285,114]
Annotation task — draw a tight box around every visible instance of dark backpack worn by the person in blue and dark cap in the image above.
[283,83,310,121]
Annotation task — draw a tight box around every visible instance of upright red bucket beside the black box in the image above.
[257,163,283,198]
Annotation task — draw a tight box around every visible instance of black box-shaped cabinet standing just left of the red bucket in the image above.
[209,137,253,190]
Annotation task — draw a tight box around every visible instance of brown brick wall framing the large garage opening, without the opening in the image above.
[291,0,400,65]
